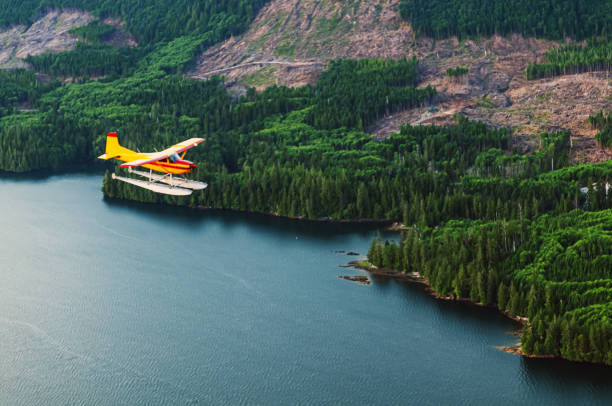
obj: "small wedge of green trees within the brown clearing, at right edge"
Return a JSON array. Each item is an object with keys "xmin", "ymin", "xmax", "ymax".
[{"xmin": 525, "ymin": 40, "xmax": 612, "ymax": 80}]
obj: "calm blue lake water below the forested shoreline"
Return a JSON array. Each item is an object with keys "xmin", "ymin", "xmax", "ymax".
[{"xmin": 0, "ymin": 174, "xmax": 612, "ymax": 405}]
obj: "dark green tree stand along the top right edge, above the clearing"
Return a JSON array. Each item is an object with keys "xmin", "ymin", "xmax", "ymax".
[{"xmin": 400, "ymin": 0, "xmax": 612, "ymax": 40}]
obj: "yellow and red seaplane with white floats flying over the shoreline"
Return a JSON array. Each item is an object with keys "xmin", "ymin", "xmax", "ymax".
[{"xmin": 98, "ymin": 132, "xmax": 208, "ymax": 196}]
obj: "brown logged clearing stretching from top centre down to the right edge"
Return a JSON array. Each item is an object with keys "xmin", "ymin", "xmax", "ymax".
[{"xmin": 189, "ymin": 0, "xmax": 612, "ymax": 162}]
